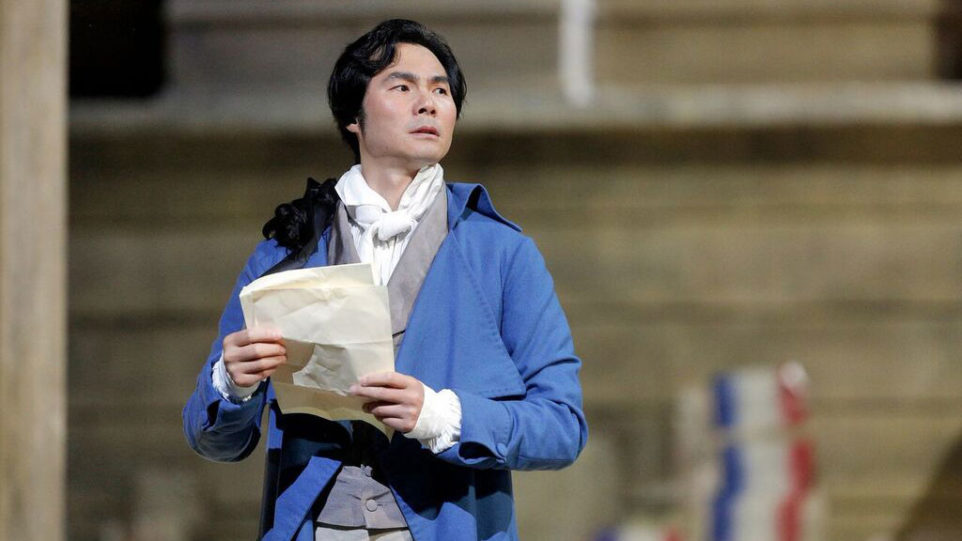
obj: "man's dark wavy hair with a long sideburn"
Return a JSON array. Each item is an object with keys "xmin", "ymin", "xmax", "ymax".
[{"xmin": 327, "ymin": 19, "xmax": 468, "ymax": 163}]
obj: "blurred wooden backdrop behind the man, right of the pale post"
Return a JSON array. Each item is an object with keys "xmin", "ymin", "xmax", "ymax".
[{"xmin": 35, "ymin": 0, "xmax": 962, "ymax": 541}]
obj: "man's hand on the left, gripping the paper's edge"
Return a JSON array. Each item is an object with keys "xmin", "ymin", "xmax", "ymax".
[{"xmin": 224, "ymin": 327, "xmax": 287, "ymax": 387}]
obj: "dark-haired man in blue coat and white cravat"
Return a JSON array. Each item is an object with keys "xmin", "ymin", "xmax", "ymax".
[{"xmin": 184, "ymin": 20, "xmax": 587, "ymax": 541}]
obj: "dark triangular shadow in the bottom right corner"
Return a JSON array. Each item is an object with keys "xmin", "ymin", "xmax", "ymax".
[{"xmin": 895, "ymin": 435, "xmax": 962, "ymax": 541}]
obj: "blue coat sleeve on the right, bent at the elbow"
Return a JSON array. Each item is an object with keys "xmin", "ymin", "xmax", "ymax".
[{"xmin": 438, "ymin": 238, "xmax": 588, "ymax": 470}]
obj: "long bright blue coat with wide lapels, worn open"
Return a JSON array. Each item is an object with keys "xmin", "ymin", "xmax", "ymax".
[{"xmin": 184, "ymin": 184, "xmax": 588, "ymax": 541}]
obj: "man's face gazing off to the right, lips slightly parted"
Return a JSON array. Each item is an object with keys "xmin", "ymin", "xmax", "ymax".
[{"xmin": 347, "ymin": 43, "xmax": 457, "ymax": 171}]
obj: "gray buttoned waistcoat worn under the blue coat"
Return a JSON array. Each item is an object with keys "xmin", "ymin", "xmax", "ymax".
[{"xmin": 317, "ymin": 190, "xmax": 448, "ymax": 528}]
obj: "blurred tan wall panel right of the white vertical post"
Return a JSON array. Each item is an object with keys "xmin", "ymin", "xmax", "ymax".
[{"xmin": 595, "ymin": 0, "xmax": 939, "ymax": 83}]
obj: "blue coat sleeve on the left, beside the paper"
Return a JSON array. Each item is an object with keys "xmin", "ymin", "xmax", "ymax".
[{"xmin": 183, "ymin": 243, "xmax": 282, "ymax": 462}]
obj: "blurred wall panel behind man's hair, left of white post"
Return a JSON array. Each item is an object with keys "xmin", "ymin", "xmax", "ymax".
[{"xmin": 169, "ymin": 0, "xmax": 558, "ymax": 94}]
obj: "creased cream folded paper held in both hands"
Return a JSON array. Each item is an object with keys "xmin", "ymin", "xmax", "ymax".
[{"xmin": 240, "ymin": 263, "xmax": 394, "ymax": 437}]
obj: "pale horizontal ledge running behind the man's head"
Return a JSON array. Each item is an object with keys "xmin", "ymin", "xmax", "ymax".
[{"xmin": 70, "ymin": 81, "xmax": 962, "ymax": 137}]
